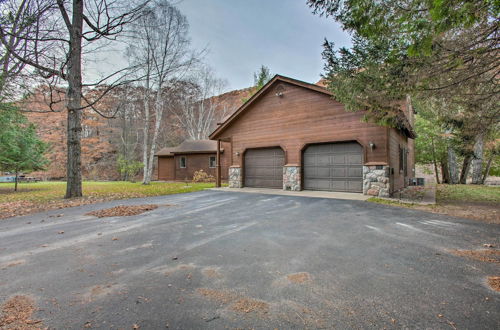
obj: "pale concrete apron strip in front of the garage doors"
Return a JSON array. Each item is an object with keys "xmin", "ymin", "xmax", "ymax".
[{"xmin": 209, "ymin": 187, "xmax": 373, "ymax": 201}]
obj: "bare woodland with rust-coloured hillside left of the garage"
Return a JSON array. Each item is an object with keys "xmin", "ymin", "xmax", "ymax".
[{"xmin": 0, "ymin": 0, "xmax": 247, "ymax": 197}]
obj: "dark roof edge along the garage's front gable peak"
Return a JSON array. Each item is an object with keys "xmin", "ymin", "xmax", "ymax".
[{"xmin": 210, "ymin": 74, "xmax": 333, "ymax": 139}]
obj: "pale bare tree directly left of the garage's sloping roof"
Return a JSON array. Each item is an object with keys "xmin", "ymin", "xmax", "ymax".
[{"xmin": 172, "ymin": 67, "xmax": 227, "ymax": 140}]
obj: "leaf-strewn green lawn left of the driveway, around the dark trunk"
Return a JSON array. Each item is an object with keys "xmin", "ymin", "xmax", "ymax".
[{"xmin": 0, "ymin": 181, "xmax": 214, "ymax": 218}]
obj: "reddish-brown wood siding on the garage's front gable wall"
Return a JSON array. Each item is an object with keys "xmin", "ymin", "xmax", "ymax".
[{"xmin": 219, "ymin": 82, "xmax": 388, "ymax": 166}]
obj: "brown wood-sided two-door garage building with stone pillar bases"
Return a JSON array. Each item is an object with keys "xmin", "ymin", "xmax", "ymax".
[{"xmin": 210, "ymin": 75, "xmax": 415, "ymax": 196}]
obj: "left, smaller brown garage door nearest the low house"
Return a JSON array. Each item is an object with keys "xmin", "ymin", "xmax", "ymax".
[{"xmin": 245, "ymin": 148, "xmax": 285, "ymax": 189}]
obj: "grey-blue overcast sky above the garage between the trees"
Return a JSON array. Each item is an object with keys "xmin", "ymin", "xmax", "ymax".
[{"xmin": 176, "ymin": 0, "xmax": 350, "ymax": 90}]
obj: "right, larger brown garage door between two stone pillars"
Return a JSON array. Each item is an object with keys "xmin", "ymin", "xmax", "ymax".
[{"xmin": 304, "ymin": 142, "xmax": 363, "ymax": 192}]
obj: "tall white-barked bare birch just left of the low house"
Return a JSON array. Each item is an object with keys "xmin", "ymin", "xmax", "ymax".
[{"xmin": 129, "ymin": 0, "xmax": 197, "ymax": 184}]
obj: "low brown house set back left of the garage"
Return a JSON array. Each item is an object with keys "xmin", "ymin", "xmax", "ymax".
[{"xmin": 156, "ymin": 140, "xmax": 227, "ymax": 181}]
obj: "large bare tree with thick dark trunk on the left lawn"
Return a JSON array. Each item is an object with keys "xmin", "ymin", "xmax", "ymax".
[{"xmin": 0, "ymin": 0, "xmax": 144, "ymax": 198}]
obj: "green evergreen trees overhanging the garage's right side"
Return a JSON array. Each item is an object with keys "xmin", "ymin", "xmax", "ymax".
[{"xmin": 308, "ymin": 0, "xmax": 500, "ymax": 184}]
